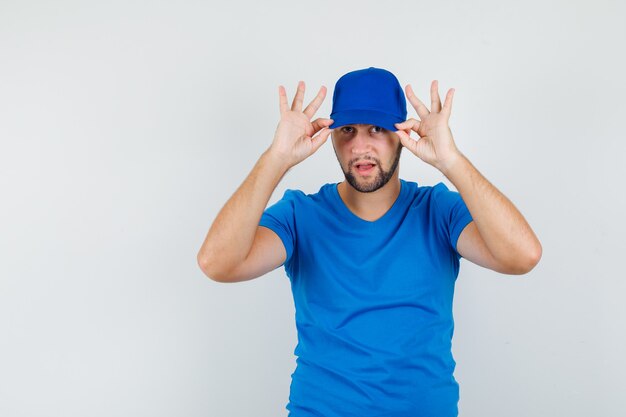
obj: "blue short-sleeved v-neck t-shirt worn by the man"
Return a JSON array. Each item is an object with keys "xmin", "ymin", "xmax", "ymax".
[{"xmin": 259, "ymin": 179, "xmax": 472, "ymax": 417}]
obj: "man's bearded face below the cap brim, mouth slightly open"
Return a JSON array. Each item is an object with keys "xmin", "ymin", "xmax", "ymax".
[{"xmin": 332, "ymin": 124, "xmax": 402, "ymax": 193}]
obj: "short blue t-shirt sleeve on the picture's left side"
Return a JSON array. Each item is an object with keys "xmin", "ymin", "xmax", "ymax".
[{"xmin": 259, "ymin": 190, "xmax": 296, "ymax": 266}]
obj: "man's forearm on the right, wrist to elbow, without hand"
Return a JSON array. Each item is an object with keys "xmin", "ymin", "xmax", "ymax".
[{"xmin": 442, "ymin": 152, "xmax": 541, "ymax": 265}]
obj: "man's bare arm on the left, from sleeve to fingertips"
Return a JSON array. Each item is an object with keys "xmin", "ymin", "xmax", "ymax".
[{"xmin": 197, "ymin": 81, "xmax": 333, "ymax": 281}]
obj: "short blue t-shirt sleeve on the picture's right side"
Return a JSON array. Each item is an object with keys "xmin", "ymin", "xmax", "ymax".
[{"xmin": 433, "ymin": 182, "xmax": 473, "ymax": 258}]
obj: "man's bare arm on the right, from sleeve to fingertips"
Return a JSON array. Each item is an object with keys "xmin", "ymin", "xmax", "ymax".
[{"xmin": 396, "ymin": 80, "xmax": 542, "ymax": 274}]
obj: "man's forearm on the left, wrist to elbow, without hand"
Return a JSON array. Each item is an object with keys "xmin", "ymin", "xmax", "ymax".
[{"xmin": 197, "ymin": 149, "xmax": 289, "ymax": 275}]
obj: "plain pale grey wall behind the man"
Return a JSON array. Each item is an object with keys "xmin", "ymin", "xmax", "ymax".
[{"xmin": 0, "ymin": 0, "xmax": 626, "ymax": 417}]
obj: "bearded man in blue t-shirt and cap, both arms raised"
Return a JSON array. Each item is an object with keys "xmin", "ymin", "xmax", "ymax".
[{"xmin": 198, "ymin": 67, "xmax": 541, "ymax": 417}]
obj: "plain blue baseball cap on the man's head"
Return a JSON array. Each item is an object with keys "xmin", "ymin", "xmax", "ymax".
[{"xmin": 329, "ymin": 67, "xmax": 406, "ymax": 132}]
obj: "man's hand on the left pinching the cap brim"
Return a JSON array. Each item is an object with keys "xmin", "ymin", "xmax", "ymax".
[{"xmin": 269, "ymin": 81, "xmax": 333, "ymax": 168}]
